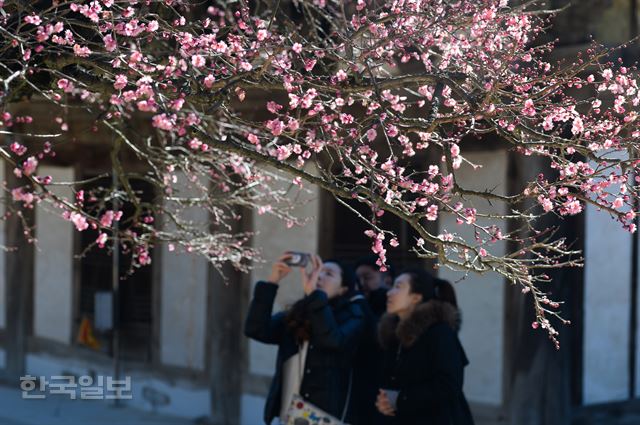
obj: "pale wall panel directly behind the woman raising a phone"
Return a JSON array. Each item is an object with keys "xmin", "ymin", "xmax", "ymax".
[{"xmin": 249, "ymin": 179, "xmax": 321, "ymax": 376}]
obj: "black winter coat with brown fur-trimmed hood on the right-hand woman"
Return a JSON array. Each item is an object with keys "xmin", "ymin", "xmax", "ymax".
[{"xmin": 380, "ymin": 300, "xmax": 473, "ymax": 425}]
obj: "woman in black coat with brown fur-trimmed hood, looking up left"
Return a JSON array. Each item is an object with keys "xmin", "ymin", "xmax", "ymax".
[{"xmin": 376, "ymin": 269, "xmax": 473, "ymax": 425}]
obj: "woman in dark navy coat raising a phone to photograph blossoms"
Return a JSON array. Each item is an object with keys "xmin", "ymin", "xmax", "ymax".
[{"xmin": 245, "ymin": 254, "xmax": 364, "ymax": 424}]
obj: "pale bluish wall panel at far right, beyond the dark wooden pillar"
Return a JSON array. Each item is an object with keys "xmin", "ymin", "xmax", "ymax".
[{"xmin": 583, "ymin": 206, "xmax": 631, "ymax": 404}]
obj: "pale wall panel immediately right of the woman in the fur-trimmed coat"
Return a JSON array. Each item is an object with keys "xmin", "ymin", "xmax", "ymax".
[{"xmin": 438, "ymin": 151, "xmax": 507, "ymax": 405}]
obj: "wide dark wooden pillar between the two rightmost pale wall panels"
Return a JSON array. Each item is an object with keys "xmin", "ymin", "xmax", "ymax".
[{"xmin": 505, "ymin": 155, "xmax": 584, "ymax": 425}]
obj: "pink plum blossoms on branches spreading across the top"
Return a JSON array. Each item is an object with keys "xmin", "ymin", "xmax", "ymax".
[{"xmin": 0, "ymin": 0, "xmax": 640, "ymax": 336}]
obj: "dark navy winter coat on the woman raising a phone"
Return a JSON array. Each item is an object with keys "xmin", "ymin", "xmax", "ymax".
[{"xmin": 245, "ymin": 282, "xmax": 364, "ymax": 424}]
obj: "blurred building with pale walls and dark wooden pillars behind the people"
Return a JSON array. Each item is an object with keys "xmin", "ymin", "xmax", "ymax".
[{"xmin": 0, "ymin": 0, "xmax": 640, "ymax": 425}]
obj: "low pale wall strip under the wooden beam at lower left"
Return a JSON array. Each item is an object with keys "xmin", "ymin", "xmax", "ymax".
[{"xmin": 26, "ymin": 354, "xmax": 211, "ymax": 419}]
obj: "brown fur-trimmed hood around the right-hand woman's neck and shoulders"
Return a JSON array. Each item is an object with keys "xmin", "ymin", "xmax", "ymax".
[{"xmin": 378, "ymin": 300, "xmax": 460, "ymax": 349}]
